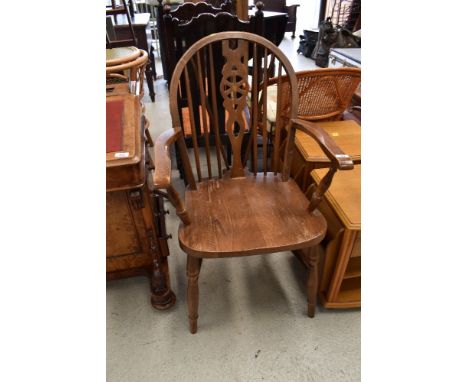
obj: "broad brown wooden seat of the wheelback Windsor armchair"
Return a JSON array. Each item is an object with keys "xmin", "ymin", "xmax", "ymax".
[{"xmin": 179, "ymin": 173, "xmax": 327, "ymax": 257}]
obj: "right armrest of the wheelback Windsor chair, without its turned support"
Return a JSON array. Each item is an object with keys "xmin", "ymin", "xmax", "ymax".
[{"xmin": 291, "ymin": 118, "xmax": 354, "ymax": 170}]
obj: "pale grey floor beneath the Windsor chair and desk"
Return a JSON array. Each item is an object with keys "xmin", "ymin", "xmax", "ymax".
[{"xmin": 107, "ymin": 39, "xmax": 361, "ymax": 382}]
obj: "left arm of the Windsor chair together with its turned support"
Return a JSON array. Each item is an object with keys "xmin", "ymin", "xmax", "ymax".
[{"xmin": 153, "ymin": 128, "xmax": 190, "ymax": 225}]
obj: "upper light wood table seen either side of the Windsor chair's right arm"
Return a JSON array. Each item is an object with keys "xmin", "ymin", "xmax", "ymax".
[{"xmin": 291, "ymin": 120, "xmax": 361, "ymax": 191}]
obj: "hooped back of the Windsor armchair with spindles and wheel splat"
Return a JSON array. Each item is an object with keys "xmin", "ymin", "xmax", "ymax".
[{"xmin": 169, "ymin": 32, "xmax": 298, "ymax": 188}]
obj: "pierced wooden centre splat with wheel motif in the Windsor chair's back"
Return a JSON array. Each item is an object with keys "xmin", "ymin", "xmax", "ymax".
[{"xmin": 220, "ymin": 40, "xmax": 249, "ymax": 178}]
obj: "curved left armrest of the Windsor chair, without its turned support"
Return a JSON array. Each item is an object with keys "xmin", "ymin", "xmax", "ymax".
[{"xmin": 153, "ymin": 129, "xmax": 181, "ymax": 189}]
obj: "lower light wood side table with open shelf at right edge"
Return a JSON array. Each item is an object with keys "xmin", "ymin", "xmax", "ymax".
[{"xmin": 311, "ymin": 165, "xmax": 361, "ymax": 308}]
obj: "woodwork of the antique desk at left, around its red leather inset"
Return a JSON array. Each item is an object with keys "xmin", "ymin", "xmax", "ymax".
[{"xmin": 106, "ymin": 93, "xmax": 175, "ymax": 309}]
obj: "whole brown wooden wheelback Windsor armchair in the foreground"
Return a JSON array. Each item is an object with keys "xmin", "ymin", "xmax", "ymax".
[{"xmin": 153, "ymin": 32, "xmax": 353, "ymax": 333}]
